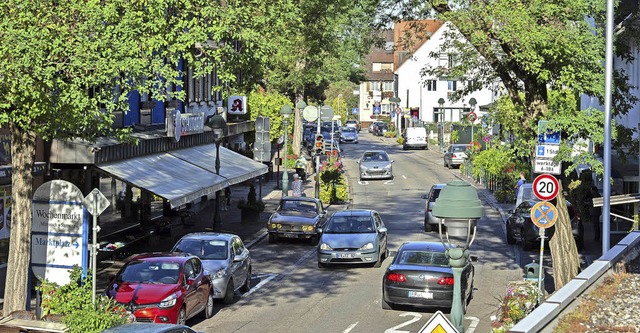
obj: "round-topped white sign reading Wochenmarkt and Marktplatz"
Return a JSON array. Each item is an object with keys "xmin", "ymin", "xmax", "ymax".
[{"xmin": 31, "ymin": 180, "xmax": 89, "ymax": 285}]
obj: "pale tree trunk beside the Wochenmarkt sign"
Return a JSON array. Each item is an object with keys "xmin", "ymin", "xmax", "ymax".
[{"xmin": 3, "ymin": 123, "xmax": 36, "ymax": 315}]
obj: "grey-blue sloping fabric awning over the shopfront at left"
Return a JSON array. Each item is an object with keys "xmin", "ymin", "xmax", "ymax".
[{"xmin": 97, "ymin": 145, "xmax": 268, "ymax": 208}]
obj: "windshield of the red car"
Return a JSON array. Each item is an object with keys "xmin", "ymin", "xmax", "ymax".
[{"xmin": 116, "ymin": 260, "xmax": 180, "ymax": 284}]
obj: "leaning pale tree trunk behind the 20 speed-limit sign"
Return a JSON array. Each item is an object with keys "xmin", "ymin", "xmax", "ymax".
[{"xmin": 549, "ymin": 185, "xmax": 580, "ymax": 290}]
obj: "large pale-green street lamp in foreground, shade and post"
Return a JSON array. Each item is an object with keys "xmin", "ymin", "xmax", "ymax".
[{"xmin": 433, "ymin": 180, "xmax": 483, "ymax": 332}]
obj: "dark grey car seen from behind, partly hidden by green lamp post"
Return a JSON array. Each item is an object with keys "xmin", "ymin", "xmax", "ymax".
[{"xmin": 382, "ymin": 242, "xmax": 475, "ymax": 309}]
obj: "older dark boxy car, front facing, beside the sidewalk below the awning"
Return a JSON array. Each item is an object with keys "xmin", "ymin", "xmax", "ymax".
[{"xmin": 267, "ymin": 197, "xmax": 327, "ymax": 245}]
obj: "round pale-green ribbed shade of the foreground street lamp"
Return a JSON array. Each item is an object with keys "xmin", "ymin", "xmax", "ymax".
[{"xmin": 433, "ymin": 180, "xmax": 484, "ymax": 219}]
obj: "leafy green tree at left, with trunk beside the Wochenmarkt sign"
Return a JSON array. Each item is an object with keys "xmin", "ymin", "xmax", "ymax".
[{"xmin": 0, "ymin": 0, "xmax": 288, "ymax": 313}]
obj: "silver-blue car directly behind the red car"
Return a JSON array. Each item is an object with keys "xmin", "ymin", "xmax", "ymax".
[{"xmin": 171, "ymin": 232, "xmax": 251, "ymax": 304}]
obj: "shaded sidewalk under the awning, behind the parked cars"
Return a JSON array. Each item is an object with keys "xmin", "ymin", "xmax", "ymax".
[{"xmin": 96, "ymin": 172, "xmax": 315, "ymax": 293}]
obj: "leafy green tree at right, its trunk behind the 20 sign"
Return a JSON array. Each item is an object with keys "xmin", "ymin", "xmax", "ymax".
[{"xmin": 384, "ymin": 0, "xmax": 637, "ymax": 288}]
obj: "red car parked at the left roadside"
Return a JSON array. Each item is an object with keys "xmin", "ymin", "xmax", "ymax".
[{"xmin": 105, "ymin": 253, "xmax": 213, "ymax": 325}]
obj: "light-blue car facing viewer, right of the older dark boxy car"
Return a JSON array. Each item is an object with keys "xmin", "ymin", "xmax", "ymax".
[{"xmin": 318, "ymin": 209, "xmax": 389, "ymax": 268}]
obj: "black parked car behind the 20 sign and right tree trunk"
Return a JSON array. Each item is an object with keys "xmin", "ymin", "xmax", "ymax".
[{"xmin": 507, "ymin": 200, "xmax": 584, "ymax": 251}]
